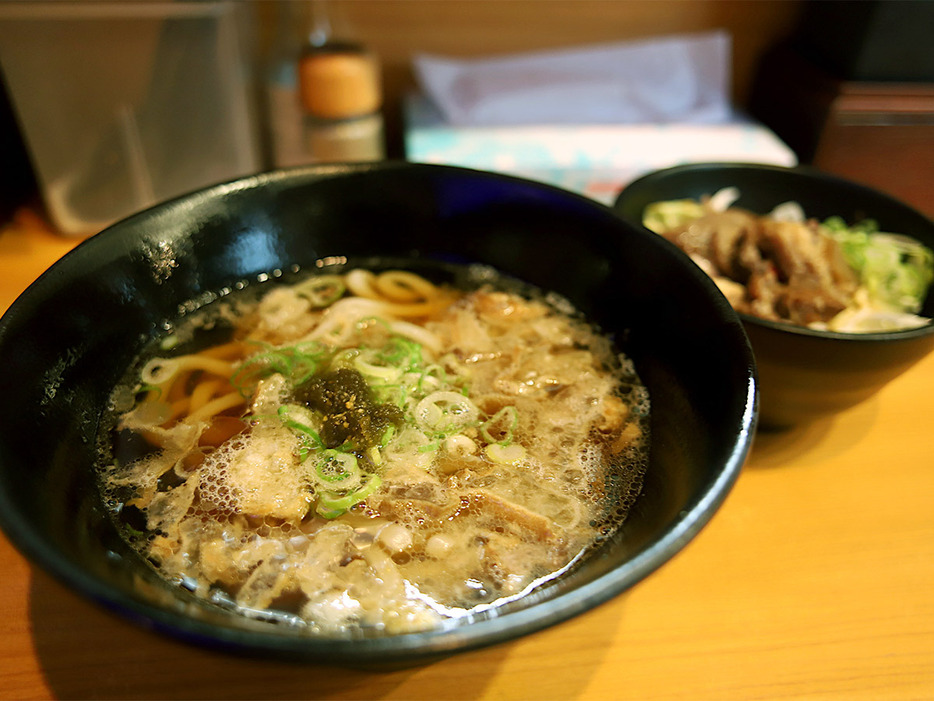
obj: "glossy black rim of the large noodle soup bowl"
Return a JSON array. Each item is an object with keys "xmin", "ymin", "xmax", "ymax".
[{"xmin": 0, "ymin": 162, "xmax": 758, "ymax": 667}]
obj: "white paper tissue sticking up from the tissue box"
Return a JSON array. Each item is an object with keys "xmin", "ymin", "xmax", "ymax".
[{"xmin": 414, "ymin": 31, "xmax": 732, "ymax": 126}]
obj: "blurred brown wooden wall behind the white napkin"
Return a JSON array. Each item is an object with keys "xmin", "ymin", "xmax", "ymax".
[{"xmin": 257, "ymin": 0, "xmax": 803, "ymax": 156}]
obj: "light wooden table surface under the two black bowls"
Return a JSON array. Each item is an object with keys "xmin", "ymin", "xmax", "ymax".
[{"xmin": 0, "ymin": 213, "xmax": 934, "ymax": 701}]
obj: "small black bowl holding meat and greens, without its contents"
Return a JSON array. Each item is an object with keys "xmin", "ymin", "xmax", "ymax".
[{"xmin": 614, "ymin": 163, "xmax": 934, "ymax": 428}]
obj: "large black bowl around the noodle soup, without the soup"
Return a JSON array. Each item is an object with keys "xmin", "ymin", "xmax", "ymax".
[{"xmin": 0, "ymin": 164, "xmax": 756, "ymax": 665}]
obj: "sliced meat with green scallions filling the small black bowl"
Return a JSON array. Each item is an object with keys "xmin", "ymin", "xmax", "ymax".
[{"xmin": 643, "ymin": 188, "xmax": 934, "ymax": 332}]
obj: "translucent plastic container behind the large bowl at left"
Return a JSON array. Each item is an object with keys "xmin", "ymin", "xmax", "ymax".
[{"xmin": 0, "ymin": 2, "xmax": 261, "ymax": 235}]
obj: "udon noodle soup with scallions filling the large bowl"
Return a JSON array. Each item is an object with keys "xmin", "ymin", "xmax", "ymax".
[{"xmin": 102, "ymin": 269, "xmax": 648, "ymax": 634}]
